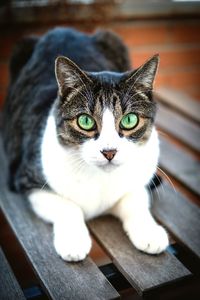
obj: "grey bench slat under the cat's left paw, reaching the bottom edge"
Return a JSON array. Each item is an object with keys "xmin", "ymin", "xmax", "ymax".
[{"xmin": 0, "ymin": 138, "xmax": 119, "ymax": 300}]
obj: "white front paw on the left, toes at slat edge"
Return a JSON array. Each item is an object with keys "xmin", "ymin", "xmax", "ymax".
[{"xmin": 54, "ymin": 224, "xmax": 92, "ymax": 262}]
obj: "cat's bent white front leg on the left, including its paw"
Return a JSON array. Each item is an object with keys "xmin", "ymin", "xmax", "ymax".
[{"xmin": 29, "ymin": 190, "xmax": 92, "ymax": 261}]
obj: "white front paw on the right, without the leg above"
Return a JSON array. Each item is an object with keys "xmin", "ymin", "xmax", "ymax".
[{"xmin": 126, "ymin": 224, "xmax": 169, "ymax": 254}]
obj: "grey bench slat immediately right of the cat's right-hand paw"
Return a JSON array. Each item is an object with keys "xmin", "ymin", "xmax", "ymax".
[{"xmin": 153, "ymin": 181, "xmax": 200, "ymax": 258}]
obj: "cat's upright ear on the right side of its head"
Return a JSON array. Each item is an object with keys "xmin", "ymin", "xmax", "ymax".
[{"xmin": 126, "ymin": 54, "xmax": 160, "ymax": 90}]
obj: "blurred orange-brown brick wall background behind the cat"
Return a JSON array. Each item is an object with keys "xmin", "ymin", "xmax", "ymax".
[{"xmin": 0, "ymin": 0, "xmax": 200, "ymax": 106}]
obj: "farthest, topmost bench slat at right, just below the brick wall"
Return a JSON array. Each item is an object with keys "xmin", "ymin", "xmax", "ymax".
[{"xmin": 155, "ymin": 87, "xmax": 200, "ymax": 122}]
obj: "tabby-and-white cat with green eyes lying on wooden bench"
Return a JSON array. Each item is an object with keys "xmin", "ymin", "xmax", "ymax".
[{"xmin": 3, "ymin": 28, "xmax": 168, "ymax": 261}]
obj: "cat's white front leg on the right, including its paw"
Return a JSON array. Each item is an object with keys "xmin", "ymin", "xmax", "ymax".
[{"xmin": 110, "ymin": 188, "xmax": 169, "ymax": 254}]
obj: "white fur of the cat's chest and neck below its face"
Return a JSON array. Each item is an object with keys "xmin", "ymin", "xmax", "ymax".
[{"xmin": 41, "ymin": 116, "xmax": 158, "ymax": 219}]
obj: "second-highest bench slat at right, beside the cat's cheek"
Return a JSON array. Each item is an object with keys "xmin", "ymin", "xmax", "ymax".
[{"xmin": 156, "ymin": 103, "xmax": 200, "ymax": 151}]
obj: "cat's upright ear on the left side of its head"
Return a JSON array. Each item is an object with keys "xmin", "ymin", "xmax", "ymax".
[{"xmin": 55, "ymin": 56, "xmax": 92, "ymax": 96}]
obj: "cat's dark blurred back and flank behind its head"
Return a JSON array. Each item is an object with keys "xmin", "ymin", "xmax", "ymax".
[{"xmin": 3, "ymin": 28, "xmax": 129, "ymax": 192}]
